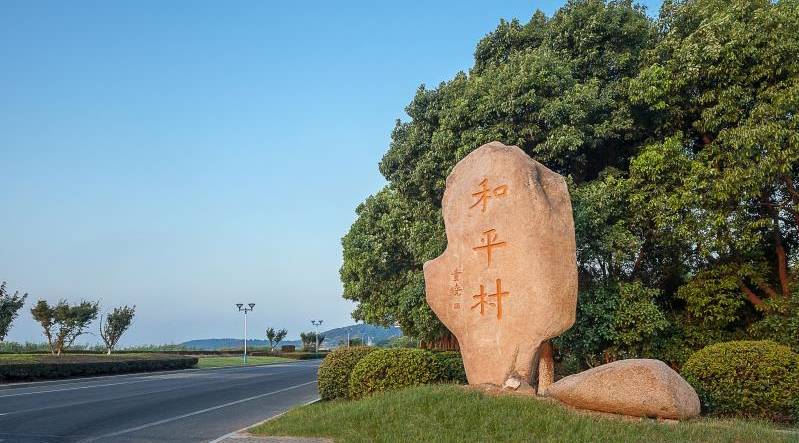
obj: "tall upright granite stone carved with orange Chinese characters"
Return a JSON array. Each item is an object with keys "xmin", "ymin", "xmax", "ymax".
[{"xmin": 424, "ymin": 142, "xmax": 577, "ymax": 386}]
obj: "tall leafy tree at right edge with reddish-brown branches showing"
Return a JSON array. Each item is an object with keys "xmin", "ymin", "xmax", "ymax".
[{"xmin": 629, "ymin": 0, "xmax": 799, "ymax": 358}]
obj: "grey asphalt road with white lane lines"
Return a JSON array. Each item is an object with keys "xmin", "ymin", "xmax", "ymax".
[{"xmin": 0, "ymin": 361, "xmax": 319, "ymax": 443}]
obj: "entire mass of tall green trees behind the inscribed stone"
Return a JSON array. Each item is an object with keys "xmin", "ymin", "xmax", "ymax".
[{"xmin": 341, "ymin": 0, "xmax": 799, "ymax": 369}]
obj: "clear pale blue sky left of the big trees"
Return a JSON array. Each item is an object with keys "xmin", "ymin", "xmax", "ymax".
[{"xmin": 0, "ymin": 0, "xmax": 656, "ymax": 345}]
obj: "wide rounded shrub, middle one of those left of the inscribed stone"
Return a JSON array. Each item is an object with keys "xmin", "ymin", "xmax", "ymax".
[{"xmin": 349, "ymin": 348, "xmax": 442, "ymax": 399}]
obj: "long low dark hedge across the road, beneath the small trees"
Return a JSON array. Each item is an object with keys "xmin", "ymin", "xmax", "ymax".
[{"xmin": 0, "ymin": 354, "xmax": 197, "ymax": 381}]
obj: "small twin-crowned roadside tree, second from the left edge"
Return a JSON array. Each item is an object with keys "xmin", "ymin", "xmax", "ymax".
[{"xmin": 31, "ymin": 300, "xmax": 100, "ymax": 355}]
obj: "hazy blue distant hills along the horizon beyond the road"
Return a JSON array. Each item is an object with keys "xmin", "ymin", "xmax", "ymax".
[{"xmin": 181, "ymin": 325, "xmax": 402, "ymax": 351}]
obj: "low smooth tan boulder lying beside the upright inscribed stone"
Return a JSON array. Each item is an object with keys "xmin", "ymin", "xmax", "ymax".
[{"xmin": 545, "ymin": 359, "xmax": 699, "ymax": 420}]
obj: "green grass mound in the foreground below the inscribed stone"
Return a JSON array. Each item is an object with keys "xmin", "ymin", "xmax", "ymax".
[{"xmin": 251, "ymin": 385, "xmax": 799, "ymax": 443}]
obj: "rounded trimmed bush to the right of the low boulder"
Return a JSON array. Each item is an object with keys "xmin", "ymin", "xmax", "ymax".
[{"xmin": 682, "ymin": 341, "xmax": 799, "ymax": 421}]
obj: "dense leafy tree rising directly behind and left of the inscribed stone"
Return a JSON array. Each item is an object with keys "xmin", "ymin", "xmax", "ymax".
[{"xmin": 341, "ymin": 1, "xmax": 655, "ymax": 340}]
